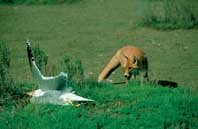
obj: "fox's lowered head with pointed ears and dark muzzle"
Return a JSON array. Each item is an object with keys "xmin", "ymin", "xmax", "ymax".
[{"xmin": 123, "ymin": 56, "xmax": 139, "ymax": 78}]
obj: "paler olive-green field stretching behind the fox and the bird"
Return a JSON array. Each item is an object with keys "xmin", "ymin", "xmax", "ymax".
[{"xmin": 0, "ymin": 0, "xmax": 198, "ymax": 87}]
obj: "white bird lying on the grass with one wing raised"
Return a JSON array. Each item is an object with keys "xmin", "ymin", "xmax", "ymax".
[{"xmin": 27, "ymin": 40, "xmax": 93, "ymax": 105}]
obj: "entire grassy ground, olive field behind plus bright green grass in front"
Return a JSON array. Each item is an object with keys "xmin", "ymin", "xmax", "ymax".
[{"xmin": 0, "ymin": 0, "xmax": 198, "ymax": 129}]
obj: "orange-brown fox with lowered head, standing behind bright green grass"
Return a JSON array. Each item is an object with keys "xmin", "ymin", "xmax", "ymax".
[{"xmin": 98, "ymin": 46, "xmax": 148, "ymax": 82}]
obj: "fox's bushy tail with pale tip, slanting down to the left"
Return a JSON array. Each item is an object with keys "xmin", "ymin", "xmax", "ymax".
[{"xmin": 98, "ymin": 53, "xmax": 120, "ymax": 82}]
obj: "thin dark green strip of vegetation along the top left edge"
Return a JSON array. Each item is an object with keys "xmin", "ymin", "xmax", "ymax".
[{"xmin": 0, "ymin": 0, "xmax": 82, "ymax": 4}]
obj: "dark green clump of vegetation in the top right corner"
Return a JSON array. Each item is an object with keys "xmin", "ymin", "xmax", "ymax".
[{"xmin": 142, "ymin": 0, "xmax": 198, "ymax": 29}]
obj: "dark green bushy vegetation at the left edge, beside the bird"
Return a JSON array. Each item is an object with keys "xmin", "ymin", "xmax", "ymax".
[{"xmin": 0, "ymin": 41, "xmax": 29, "ymax": 107}]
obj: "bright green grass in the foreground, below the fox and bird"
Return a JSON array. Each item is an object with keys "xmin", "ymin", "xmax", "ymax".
[{"xmin": 0, "ymin": 83, "xmax": 198, "ymax": 129}]
